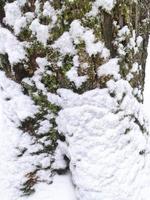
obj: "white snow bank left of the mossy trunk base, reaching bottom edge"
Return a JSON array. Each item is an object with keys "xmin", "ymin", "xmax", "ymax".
[{"xmin": 0, "ymin": 71, "xmax": 76, "ymax": 200}]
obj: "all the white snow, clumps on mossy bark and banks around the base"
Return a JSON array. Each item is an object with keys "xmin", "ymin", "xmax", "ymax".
[{"xmin": 0, "ymin": 0, "xmax": 150, "ymax": 200}]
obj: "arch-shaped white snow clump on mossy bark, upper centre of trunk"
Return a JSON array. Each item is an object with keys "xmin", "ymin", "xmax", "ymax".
[{"xmin": 52, "ymin": 20, "xmax": 110, "ymax": 59}]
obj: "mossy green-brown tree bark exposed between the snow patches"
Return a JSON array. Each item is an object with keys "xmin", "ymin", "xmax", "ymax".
[{"xmin": 0, "ymin": 0, "xmax": 150, "ymax": 197}]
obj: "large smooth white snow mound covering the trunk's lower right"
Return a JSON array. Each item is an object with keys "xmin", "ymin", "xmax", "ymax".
[{"xmin": 57, "ymin": 80, "xmax": 150, "ymax": 200}]
